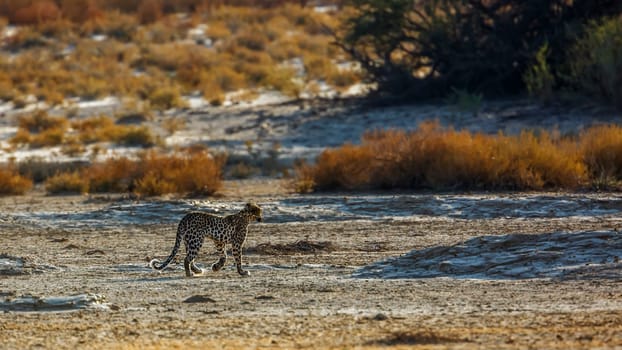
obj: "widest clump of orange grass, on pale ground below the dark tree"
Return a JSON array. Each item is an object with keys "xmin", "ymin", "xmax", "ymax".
[{"xmin": 295, "ymin": 122, "xmax": 596, "ymax": 192}]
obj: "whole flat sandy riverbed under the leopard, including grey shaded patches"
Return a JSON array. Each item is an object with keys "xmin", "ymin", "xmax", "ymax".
[{"xmin": 0, "ymin": 180, "xmax": 622, "ymax": 349}]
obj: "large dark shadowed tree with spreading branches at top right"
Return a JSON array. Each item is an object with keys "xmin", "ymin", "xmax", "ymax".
[{"xmin": 337, "ymin": 0, "xmax": 622, "ymax": 97}]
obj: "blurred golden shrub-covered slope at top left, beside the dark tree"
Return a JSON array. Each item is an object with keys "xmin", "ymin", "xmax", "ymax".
[{"xmin": 0, "ymin": 0, "xmax": 360, "ymax": 106}]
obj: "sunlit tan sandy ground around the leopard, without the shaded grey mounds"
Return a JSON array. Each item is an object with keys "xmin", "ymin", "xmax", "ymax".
[{"xmin": 0, "ymin": 182, "xmax": 622, "ymax": 349}]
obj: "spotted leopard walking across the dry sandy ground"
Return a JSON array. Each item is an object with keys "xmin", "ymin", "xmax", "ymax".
[{"xmin": 149, "ymin": 202, "xmax": 263, "ymax": 277}]
